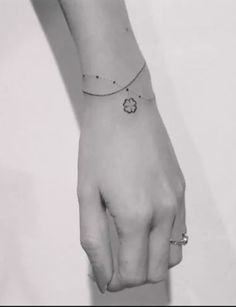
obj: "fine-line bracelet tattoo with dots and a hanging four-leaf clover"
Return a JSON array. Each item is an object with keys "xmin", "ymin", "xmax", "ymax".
[{"xmin": 83, "ymin": 62, "xmax": 155, "ymax": 114}]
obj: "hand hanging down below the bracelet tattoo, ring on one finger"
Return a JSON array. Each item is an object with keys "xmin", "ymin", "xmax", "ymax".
[{"xmin": 78, "ymin": 93, "xmax": 186, "ymax": 292}]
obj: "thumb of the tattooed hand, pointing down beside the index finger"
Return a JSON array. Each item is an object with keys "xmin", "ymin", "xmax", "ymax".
[{"xmin": 78, "ymin": 188, "xmax": 113, "ymax": 293}]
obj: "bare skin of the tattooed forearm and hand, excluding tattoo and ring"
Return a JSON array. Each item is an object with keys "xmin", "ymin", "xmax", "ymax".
[{"xmin": 60, "ymin": 0, "xmax": 186, "ymax": 292}]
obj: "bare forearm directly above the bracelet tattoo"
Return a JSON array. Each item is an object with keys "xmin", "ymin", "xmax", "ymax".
[{"xmin": 60, "ymin": 0, "xmax": 144, "ymax": 84}]
